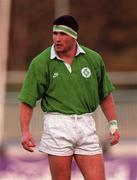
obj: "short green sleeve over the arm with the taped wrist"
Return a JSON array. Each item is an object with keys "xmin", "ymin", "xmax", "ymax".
[{"xmin": 98, "ymin": 54, "xmax": 115, "ymax": 102}]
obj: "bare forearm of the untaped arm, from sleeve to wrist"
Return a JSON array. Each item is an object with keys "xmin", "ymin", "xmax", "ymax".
[{"xmin": 20, "ymin": 103, "xmax": 33, "ymax": 133}]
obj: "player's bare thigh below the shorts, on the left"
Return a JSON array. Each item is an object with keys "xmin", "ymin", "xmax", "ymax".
[{"xmin": 48, "ymin": 155, "xmax": 72, "ymax": 180}]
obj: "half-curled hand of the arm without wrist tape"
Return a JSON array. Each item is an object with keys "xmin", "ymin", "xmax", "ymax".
[{"xmin": 21, "ymin": 132, "xmax": 36, "ymax": 152}]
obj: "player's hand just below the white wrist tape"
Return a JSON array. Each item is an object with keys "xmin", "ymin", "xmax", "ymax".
[{"xmin": 109, "ymin": 129, "xmax": 120, "ymax": 145}]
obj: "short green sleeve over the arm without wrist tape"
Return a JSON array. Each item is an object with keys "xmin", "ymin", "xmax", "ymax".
[{"xmin": 18, "ymin": 61, "xmax": 46, "ymax": 107}]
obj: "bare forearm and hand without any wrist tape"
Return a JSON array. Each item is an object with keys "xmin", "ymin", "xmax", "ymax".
[{"xmin": 20, "ymin": 103, "xmax": 36, "ymax": 152}]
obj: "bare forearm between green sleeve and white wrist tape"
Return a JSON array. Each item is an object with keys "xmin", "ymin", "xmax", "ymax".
[{"xmin": 100, "ymin": 94, "xmax": 117, "ymax": 121}]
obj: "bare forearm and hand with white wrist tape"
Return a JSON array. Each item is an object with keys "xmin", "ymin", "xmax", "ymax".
[{"xmin": 100, "ymin": 93, "xmax": 120, "ymax": 145}]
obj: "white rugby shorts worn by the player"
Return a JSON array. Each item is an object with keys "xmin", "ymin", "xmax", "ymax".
[{"xmin": 39, "ymin": 113, "xmax": 102, "ymax": 156}]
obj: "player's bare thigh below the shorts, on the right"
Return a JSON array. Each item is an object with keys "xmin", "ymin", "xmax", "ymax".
[{"xmin": 74, "ymin": 154, "xmax": 105, "ymax": 180}]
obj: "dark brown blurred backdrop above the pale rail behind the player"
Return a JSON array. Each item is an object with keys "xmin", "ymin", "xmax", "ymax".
[{"xmin": 7, "ymin": 0, "xmax": 137, "ymax": 71}]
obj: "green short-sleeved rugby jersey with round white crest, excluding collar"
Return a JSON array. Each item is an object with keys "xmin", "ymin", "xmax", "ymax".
[{"xmin": 18, "ymin": 46, "xmax": 115, "ymax": 114}]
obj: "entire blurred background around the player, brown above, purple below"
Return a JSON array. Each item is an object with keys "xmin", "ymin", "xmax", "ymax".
[{"xmin": 0, "ymin": 0, "xmax": 137, "ymax": 180}]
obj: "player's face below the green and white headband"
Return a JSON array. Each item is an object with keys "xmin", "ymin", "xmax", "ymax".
[{"xmin": 53, "ymin": 31, "xmax": 76, "ymax": 53}]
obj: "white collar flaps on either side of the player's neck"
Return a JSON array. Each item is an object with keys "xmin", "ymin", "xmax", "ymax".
[{"xmin": 50, "ymin": 43, "xmax": 85, "ymax": 60}]
